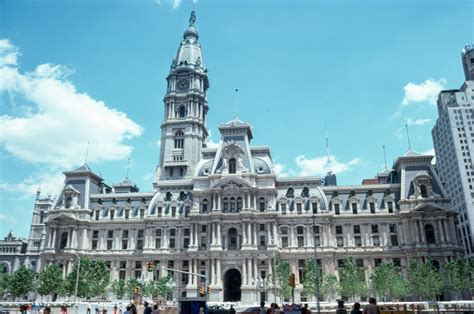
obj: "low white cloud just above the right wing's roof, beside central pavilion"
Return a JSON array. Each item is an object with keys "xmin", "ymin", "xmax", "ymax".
[{"xmin": 295, "ymin": 155, "xmax": 362, "ymax": 176}]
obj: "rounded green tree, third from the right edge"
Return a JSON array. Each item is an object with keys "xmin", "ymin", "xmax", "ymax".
[{"xmin": 370, "ymin": 262, "xmax": 408, "ymax": 300}]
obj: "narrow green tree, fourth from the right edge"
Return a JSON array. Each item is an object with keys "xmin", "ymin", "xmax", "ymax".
[{"xmin": 339, "ymin": 258, "xmax": 367, "ymax": 299}]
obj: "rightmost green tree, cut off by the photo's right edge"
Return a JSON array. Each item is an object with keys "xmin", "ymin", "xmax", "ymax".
[{"xmin": 444, "ymin": 257, "xmax": 474, "ymax": 293}]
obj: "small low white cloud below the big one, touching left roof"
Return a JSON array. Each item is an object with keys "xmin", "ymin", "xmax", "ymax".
[{"xmin": 0, "ymin": 170, "xmax": 64, "ymax": 199}]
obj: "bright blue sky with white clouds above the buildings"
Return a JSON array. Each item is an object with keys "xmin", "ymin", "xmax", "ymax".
[{"xmin": 0, "ymin": 0, "xmax": 474, "ymax": 237}]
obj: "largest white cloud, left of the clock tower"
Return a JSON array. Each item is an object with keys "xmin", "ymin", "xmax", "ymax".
[{"xmin": 0, "ymin": 41, "xmax": 142, "ymax": 172}]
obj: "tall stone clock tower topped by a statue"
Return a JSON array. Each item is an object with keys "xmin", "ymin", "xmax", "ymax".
[{"xmin": 154, "ymin": 11, "xmax": 209, "ymax": 186}]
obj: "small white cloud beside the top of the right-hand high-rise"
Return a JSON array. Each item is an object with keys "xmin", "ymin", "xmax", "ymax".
[{"xmin": 402, "ymin": 78, "xmax": 446, "ymax": 106}]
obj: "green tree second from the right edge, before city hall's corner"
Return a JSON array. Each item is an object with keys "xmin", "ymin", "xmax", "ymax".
[{"xmin": 408, "ymin": 259, "xmax": 443, "ymax": 300}]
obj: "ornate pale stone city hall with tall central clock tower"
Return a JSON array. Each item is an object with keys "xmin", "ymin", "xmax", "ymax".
[{"xmin": 0, "ymin": 12, "xmax": 462, "ymax": 302}]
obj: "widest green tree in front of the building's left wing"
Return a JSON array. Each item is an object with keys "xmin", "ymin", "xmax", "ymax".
[{"xmin": 64, "ymin": 257, "xmax": 110, "ymax": 298}]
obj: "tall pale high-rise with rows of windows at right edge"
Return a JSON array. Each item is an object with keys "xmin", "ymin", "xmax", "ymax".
[{"xmin": 432, "ymin": 45, "xmax": 474, "ymax": 257}]
